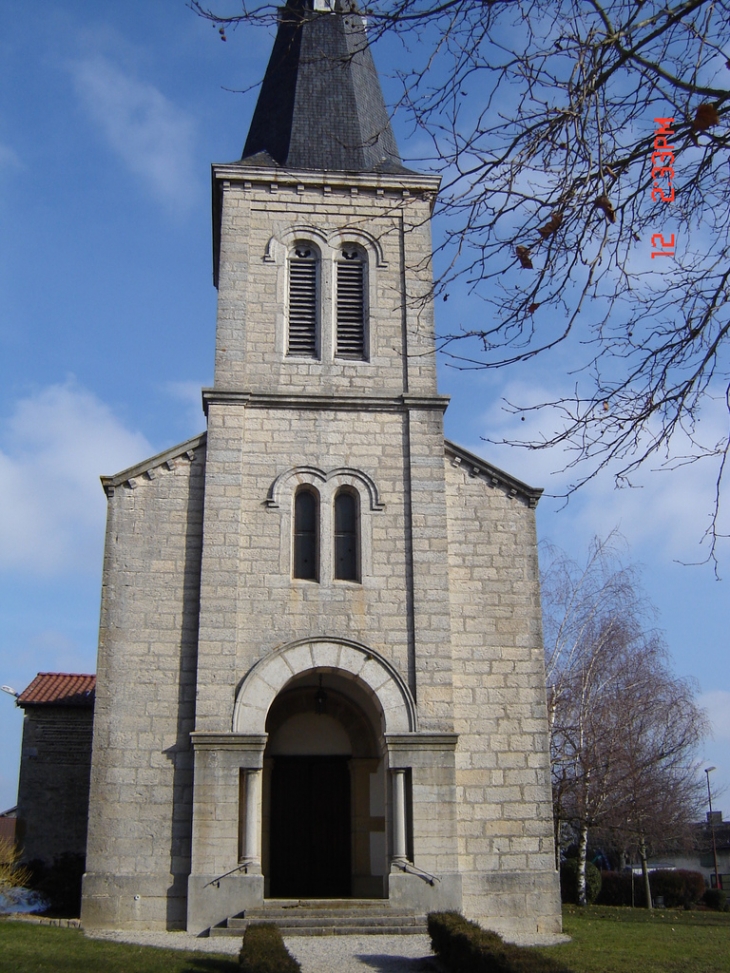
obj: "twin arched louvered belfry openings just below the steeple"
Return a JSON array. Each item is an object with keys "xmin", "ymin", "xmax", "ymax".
[{"xmin": 287, "ymin": 242, "xmax": 367, "ymax": 361}]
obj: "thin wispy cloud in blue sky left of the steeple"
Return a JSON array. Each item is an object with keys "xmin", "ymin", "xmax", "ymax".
[{"xmin": 70, "ymin": 55, "xmax": 196, "ymax": 210}]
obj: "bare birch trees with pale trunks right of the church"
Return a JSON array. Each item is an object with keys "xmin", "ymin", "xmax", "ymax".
[{"xmin": 543, "ymin": 534, "xmax": 707, "ymax": 905}]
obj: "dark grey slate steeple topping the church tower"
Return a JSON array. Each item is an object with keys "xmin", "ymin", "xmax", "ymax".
[{"xmin": 241, "ymin": 0, "xmax": 408, "ymax": 173}]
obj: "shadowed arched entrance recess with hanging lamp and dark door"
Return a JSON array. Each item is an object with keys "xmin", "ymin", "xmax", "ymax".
[{"xmin": 262, "ymin": 668, "xmax": 387, "ymax": 899}]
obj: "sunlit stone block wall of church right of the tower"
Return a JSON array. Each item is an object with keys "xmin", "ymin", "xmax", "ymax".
[{"xmin": 447, "ymin": 455, "xmax": 561, "ymax": 933}]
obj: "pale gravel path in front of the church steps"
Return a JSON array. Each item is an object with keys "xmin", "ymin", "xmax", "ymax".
[{"xmin": 87, "ymin": 932, "xmax": 441, "ymax": 973}]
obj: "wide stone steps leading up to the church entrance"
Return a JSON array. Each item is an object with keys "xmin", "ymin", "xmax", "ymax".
[{"xmin": 210, "ymin": 899, "xmax": 426, "ymax": 936}]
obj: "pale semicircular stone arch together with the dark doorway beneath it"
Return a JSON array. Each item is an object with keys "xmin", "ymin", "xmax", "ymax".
[{"xmin": 233, "ymin": 637, "xmax": 416, "ymax": 898}]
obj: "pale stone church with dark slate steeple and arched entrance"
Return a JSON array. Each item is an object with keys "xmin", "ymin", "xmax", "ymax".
[{"xmin": 82, "ymin": 0, "xmax": 561, "ymax": 935}]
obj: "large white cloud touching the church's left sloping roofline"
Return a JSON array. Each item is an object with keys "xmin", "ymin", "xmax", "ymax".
[{"xmin": 0, "ymin": 383, "xmax": 154, "ymax": 575}]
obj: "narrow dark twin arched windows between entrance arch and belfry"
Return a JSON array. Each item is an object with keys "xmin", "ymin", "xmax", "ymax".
[{"xmin": 293, "ymin": 486, "xmax": 360, "ymax": 581}]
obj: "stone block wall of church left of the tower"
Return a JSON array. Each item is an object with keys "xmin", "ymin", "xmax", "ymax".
[{"xmin": 82, "ymin": 437, "xmax": 205, "ymax": 929}]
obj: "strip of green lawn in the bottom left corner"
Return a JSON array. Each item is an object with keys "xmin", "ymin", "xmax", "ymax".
[{"xmin": 0, "ymin": 920, "xmax": 236, "ymax": 973}]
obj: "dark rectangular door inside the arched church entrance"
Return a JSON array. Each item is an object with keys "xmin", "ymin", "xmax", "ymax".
[{"xmin": 269, "ymin": 757, "xmax": 352, "ymax": 899}]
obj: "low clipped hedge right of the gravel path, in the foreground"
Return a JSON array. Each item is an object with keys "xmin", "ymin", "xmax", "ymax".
[{"xmin": 428, "ymin": 912, "xmax": 571, "ymax": 973}]
